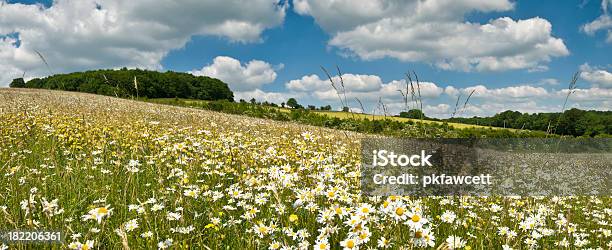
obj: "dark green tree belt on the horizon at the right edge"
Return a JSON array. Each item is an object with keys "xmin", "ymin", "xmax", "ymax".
[{"xmin": 447, "ymin": 108, "xmax": 612, "ymax": 137}]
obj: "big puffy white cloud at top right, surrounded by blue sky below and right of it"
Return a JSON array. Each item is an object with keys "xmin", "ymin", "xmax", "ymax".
[{"xmin": 294, "ymin": 0, "xmax": 569, "ymax": 71}]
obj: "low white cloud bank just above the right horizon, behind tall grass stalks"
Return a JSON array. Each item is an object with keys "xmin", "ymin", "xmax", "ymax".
[{"xmin": 285, "ymin": 71, "xmax": 612, "ymax": 118}]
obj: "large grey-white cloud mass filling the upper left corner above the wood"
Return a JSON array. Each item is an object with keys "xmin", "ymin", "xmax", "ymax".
[{"xmin": 0, "ymin": 0, "xmax": 287, "ymax": 86}]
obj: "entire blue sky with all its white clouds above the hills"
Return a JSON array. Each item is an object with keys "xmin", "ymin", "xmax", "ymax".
[{"xmin": 0, "ymin": 0, "xmax": 612, "ymax": 117}]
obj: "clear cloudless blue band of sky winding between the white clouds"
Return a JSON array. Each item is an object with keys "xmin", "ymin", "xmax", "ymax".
[{"xmin": 162, "ymin": 1, "xmax": 612, "ymax": 90}]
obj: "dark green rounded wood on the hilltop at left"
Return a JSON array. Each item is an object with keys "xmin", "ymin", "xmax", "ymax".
[{"xmin": 11, "ymin": 68, "xmax": 234, "ymax": 101}]
